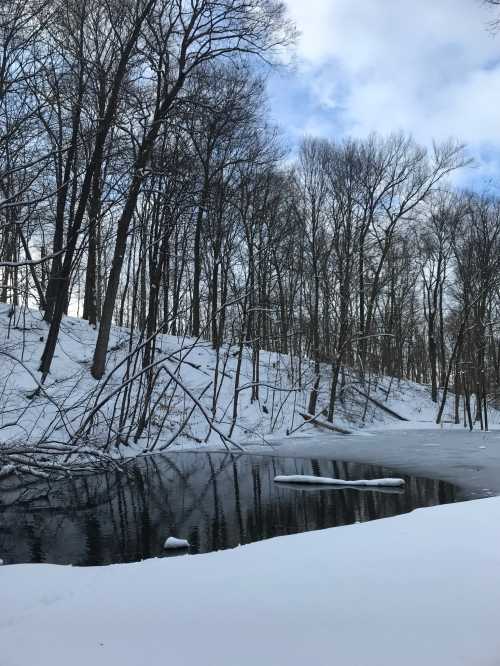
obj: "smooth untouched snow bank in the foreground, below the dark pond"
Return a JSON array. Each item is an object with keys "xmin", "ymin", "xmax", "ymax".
[{"xmin": 0, "ymin": 498, "xmax": 500, "ymax": 666}]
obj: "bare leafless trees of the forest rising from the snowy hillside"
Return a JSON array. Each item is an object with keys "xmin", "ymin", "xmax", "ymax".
[{"xmin": 0, "ymin": 0, "xmax": 500, "ymax": 472}]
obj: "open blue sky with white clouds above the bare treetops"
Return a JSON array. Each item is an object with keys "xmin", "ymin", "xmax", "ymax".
[{"xmin": 269, "ymin": 0, "xmax": 500, "ymax": 187}]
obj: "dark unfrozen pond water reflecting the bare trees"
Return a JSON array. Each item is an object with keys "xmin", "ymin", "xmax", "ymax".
[{"xmin": 0, "ymin": 453, "xmax": 458, "ymax": 565}]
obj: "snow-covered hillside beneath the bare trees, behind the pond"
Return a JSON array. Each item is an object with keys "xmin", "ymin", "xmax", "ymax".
[{"xmin": 0, "ymin": 305, "xmax": 500, "ymax": 470}]
